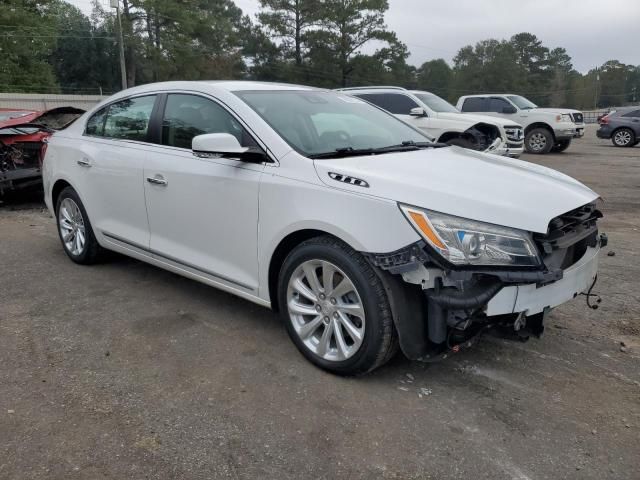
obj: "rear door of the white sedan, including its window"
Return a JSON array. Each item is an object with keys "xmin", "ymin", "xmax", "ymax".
[{"xmin": 74, "ymin": 95, "xmax": 157, "ymax": 248}]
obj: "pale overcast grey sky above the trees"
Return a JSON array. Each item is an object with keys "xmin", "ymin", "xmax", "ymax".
[{"xmin": 69, "ymin": 0, "xmax": 640, "ymax": 73}]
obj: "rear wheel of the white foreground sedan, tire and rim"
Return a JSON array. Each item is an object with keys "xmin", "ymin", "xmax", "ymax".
[{"xmin": 56, "ymin": 187, "xmax": 103, "ymax": 265}]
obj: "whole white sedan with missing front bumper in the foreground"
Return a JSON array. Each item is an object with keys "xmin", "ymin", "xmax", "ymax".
[{"xmin": 43, "ymin": 81, "xmax": 606, "ymax": 375}]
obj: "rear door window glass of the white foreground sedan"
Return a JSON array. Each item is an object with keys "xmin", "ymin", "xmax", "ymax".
[{"xmin": 103, "ymin": 95, "xmax": 156, "ymax": 142}]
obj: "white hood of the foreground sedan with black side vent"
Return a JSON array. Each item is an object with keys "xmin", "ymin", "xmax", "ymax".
[{"xmin": 314, "ymin": 147, "xmax": 598, "ymax": 233}]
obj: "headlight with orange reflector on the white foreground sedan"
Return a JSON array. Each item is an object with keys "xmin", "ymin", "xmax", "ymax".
[{"xmin": 400, "ymin": 205, "xmax": 540, "ymax": 267}]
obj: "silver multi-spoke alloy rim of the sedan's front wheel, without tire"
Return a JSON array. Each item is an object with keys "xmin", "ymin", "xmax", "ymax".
[{"xmin": 287, "ymin": 259, "xmax": 366, "ymax": 362}]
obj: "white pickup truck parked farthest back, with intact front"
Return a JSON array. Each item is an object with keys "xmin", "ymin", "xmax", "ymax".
[{"xmin": 457, "ymin": 94, "xmax": 584, "ymax": 154}]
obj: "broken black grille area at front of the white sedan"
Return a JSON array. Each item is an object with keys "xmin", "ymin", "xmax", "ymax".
[{"xmin": 533, "ymin": 203, "xmax": 602, "ymax": 270}]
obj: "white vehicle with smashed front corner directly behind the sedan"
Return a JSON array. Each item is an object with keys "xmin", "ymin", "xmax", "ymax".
[{"xmin": 338, "ymin": 87, "xmax": 524, "ymax": 158}]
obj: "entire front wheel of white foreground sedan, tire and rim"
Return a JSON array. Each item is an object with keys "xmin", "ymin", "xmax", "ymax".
[{"xmin": 278, "ymin": 236, "xmax": 397, "ymax": 375}]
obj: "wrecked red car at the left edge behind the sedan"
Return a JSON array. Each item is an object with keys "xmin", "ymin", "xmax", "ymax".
[{"xmin": 0, "ymin": 107, "xmax": 84, "ymax": 196}]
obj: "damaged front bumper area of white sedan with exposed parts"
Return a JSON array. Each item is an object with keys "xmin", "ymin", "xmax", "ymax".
[{"xmin": 367, "ymin": 206, "xmax": 607, "ymax": 361}]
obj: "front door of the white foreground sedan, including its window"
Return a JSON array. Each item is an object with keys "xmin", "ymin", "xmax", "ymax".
[{"xmin": 144, "ymin": 93, "xmax": 264, "ymax": 293}]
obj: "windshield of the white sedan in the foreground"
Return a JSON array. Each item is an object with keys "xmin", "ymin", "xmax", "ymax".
[{"xmin": 234, "ymin": 90, "xmax": 429, "ymax": 157}]
